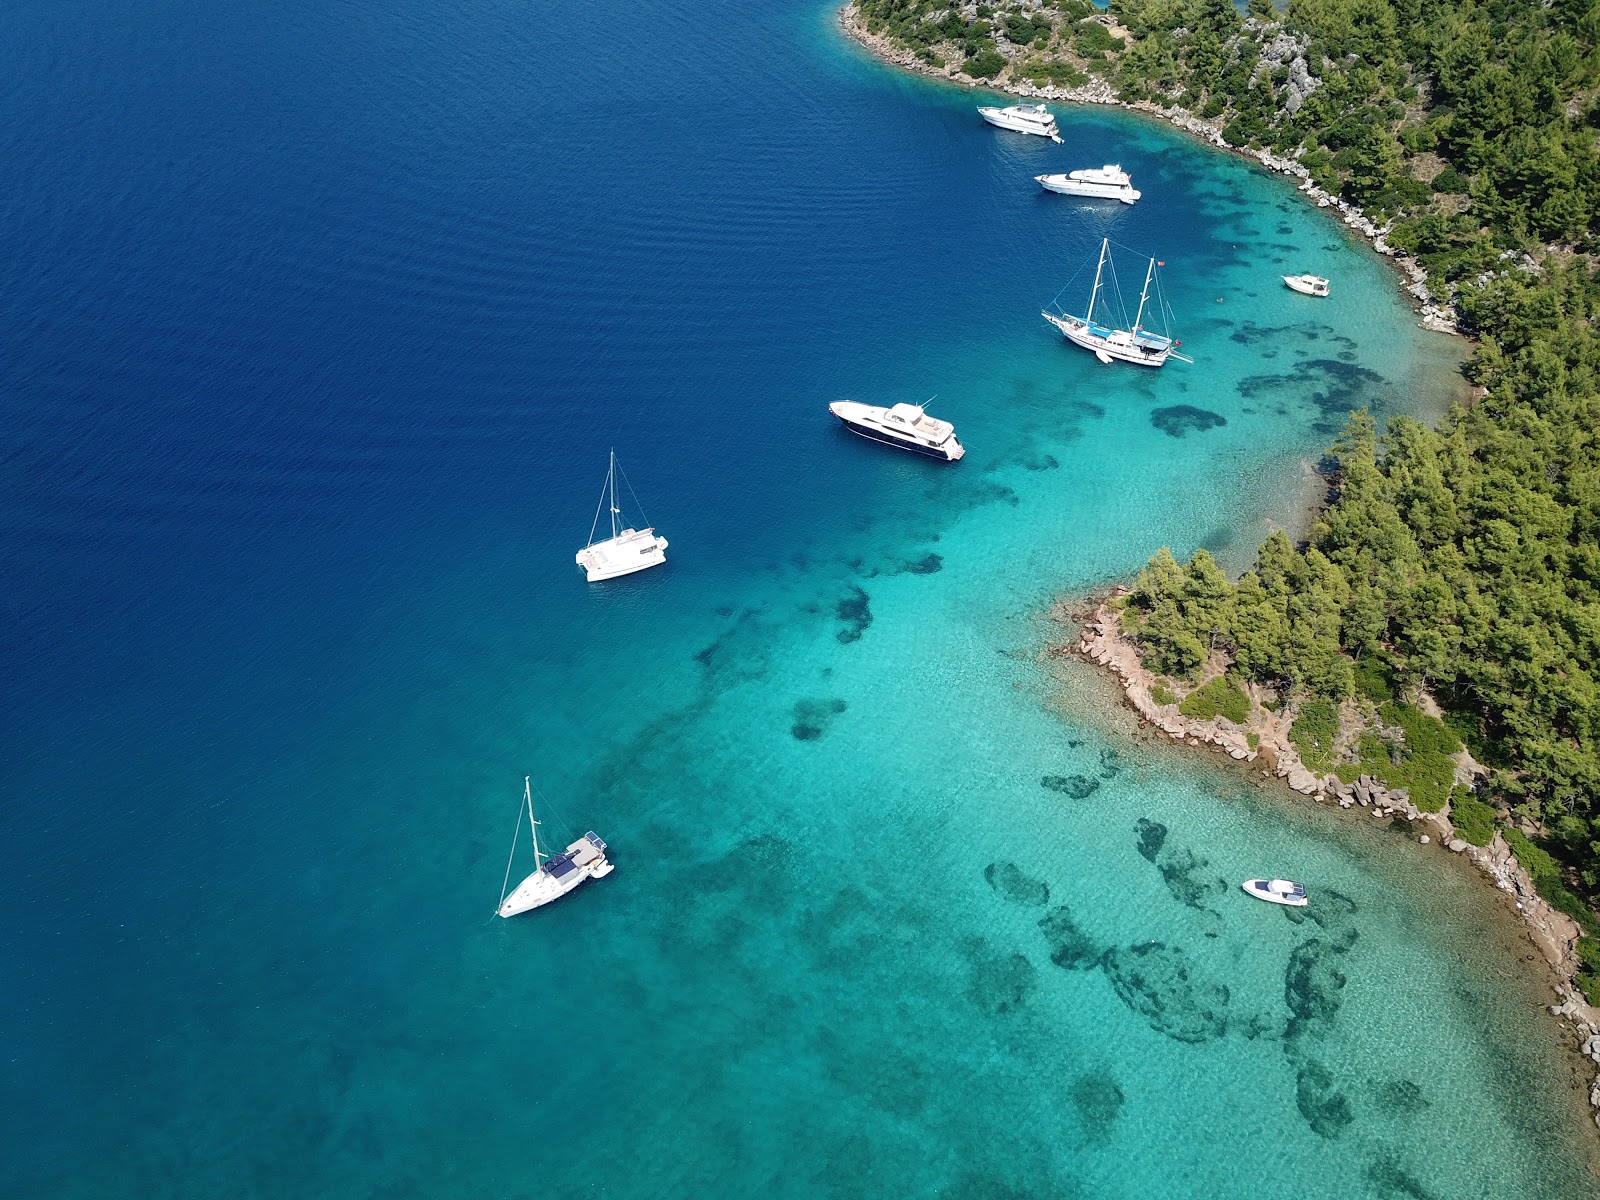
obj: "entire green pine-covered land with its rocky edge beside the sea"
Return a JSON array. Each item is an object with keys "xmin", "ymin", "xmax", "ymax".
[{"xmin": 840, "ymin": 0, "xmax": 1600, "ymax": 1122}]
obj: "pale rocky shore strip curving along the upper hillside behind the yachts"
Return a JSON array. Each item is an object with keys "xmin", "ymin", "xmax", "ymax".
[{"xmin": 838, "ymin": 3, "xmax": 1461, "ymax": 334}]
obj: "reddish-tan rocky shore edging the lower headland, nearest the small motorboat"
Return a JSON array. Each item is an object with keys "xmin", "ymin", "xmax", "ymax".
[{"xmin": 1050, "ymin": 587, "xmax": 1600, "ymax": 1125}]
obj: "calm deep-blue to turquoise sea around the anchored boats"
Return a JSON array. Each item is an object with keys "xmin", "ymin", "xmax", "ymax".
[{"xmin": 0, "ymin": 0, "xmax": 1595, "ymax": 1200}]
